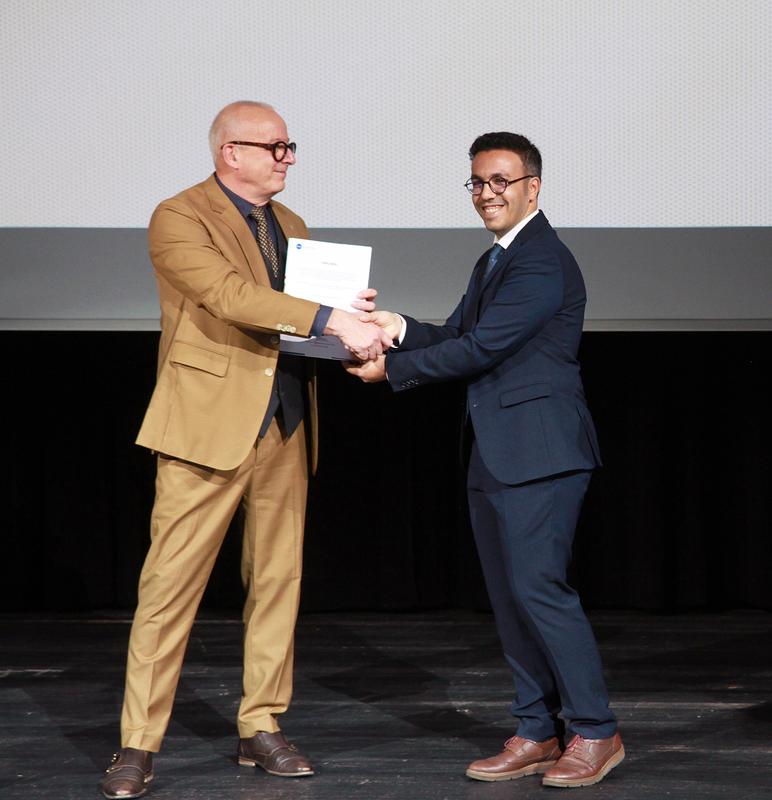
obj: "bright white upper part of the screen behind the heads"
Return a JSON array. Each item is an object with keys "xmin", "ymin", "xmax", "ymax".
[{"xmin": 0, "ymin": 0, "xmax": 772, "ymax": 229}]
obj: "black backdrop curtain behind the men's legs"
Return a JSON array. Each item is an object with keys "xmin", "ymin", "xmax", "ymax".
[{"xmin": 0, "ymin": 332, "xmax": 772, "ymax": 611}]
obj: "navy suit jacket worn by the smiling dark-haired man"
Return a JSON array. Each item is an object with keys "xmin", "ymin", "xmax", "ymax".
[{"xmin": 386, "ymin": 212, "xmax": 600, "ymax": 485}]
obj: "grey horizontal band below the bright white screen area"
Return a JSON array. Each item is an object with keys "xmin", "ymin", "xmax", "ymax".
[{"xmin": 0, "ymin": 228, "xmax": 772, "ymax": 331}]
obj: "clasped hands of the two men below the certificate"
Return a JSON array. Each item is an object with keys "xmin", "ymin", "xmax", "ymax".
[{"xmin": 324, "ymin": 289, "xmax": 402, "ymax": 383}]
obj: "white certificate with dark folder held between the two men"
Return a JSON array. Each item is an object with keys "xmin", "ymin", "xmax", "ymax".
[{"xmin": 281, "ymin": 237, "xmax": 373, "ymax": 361}]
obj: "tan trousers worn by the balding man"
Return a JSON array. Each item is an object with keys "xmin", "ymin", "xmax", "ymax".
[{"xmin": 121, "ymin": 422, "xmax": 308, "ymax": 752}]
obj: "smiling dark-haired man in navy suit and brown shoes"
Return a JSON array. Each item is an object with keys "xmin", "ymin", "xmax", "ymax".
[{"xmin": 348, "ymin": 133, "xmax": 624, "ymax": 787}]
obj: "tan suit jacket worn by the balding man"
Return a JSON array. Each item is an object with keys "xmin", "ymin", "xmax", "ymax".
[{"xmin": 137, "ymin": 176, "xmax": 319, "ymax": 470}]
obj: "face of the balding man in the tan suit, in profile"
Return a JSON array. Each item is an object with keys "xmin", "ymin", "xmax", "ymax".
[{"xmin": 215, "ymin": 106, "xmax": 295, "ymax": 205}]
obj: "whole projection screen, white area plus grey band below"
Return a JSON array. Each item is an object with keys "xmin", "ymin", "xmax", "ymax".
[{"xmin": 0, "ymin": 0, "xmax": 772, "ymax": 330}]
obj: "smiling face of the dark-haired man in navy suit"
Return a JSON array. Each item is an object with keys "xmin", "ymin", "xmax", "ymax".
[{"xmin": 472, "ymin": 150, "xmax": 541, "ymax": 238}]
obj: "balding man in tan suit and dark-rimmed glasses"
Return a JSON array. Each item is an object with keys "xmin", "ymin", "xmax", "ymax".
[{"xmin": 100, "ymin": 102, "xmax": 391, "ymax": 798}]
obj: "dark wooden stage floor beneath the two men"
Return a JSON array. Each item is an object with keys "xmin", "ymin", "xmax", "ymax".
[{"xmin": 0, "ymin": 612, "xmax": 772, "ymax": 800}]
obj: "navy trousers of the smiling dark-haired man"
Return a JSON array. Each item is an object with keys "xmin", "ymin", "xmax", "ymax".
[{"xmin": 467, "ymin": 442, "xmax": 617, "ymax": 741}]
